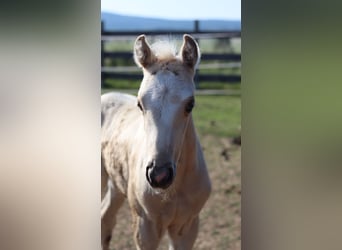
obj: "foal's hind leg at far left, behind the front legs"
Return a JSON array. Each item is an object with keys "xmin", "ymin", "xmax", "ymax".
[{"xmin": 101, "ymin": 179, "xmax": 125, "ymax": 250}]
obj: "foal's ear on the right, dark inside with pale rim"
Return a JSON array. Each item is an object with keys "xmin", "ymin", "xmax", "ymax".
[{"xmin": 181, "ymin": 34, "xmax": 201, "ymax": 69}]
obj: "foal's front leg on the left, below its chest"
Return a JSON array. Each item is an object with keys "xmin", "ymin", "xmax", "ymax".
[{"xmin": 132, "ymin": 212, "xmax": 163, "ymax": 250}]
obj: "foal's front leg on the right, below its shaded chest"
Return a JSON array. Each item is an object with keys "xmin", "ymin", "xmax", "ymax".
[{"xmin": 168, "ymin": 216, "xmax": 199, "ymax": 250}]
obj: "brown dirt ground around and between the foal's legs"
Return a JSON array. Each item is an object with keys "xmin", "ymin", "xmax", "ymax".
[{"xmin": 111, "ymin": 136, "xmax": 241, "ymax": 250}]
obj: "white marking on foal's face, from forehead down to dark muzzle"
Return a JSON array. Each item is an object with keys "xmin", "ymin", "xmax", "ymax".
[{"xmin": 138, "ymin": 70, "xmax": 194, "ymax": 165}]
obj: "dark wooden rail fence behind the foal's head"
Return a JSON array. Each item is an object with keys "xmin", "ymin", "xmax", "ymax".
[{"xmin": 101, "ymin": 21, "xmax": 241, "ymax": 87}]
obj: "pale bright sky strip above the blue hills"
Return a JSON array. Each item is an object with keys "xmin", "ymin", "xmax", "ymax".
[{"xmin": 101, "ymin": 0, "xmax": 241, "ymax": 20}]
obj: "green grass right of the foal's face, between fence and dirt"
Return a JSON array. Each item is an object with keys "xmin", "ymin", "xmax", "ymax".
[{"xmin": 193, "ymin": 95, "xmax": 241, "ymax": 137}]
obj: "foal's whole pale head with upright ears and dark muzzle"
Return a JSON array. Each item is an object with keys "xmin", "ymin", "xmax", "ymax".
[{"xmin": 134, "ymin": 35, "xmax": 200, "ymax": 189}]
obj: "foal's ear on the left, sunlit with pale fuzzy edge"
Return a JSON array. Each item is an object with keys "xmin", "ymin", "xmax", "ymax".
[{"xmin": 134, "ymin": 35, "xmax": 156, "ymax": 68}]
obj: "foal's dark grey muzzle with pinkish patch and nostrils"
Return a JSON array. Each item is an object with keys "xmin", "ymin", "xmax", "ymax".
[{"xmin": 146, "ymin": 163, "xmax": 174, "ymax": 189}]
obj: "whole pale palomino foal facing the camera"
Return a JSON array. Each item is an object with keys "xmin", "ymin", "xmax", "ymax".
[{"xmin": 101, "ymin": 35, "xmax": 211, "ymax": 249}]
